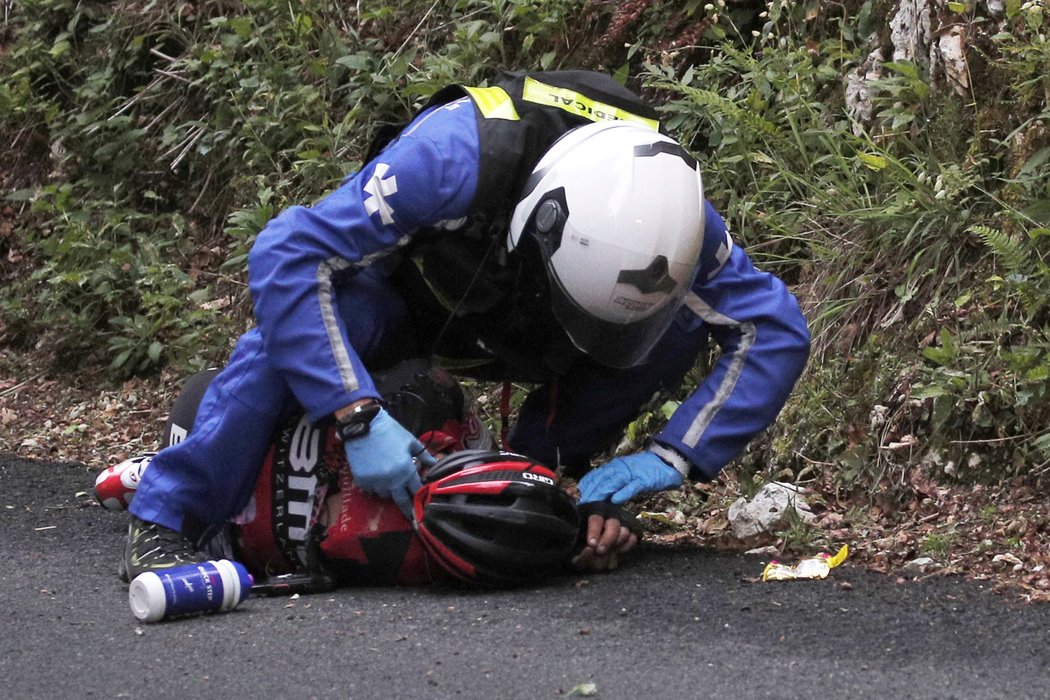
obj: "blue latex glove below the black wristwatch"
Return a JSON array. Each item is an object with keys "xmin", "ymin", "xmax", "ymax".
[{"xmin": 342, "ymin": 408, "xmax": 437, "ymax": 519}]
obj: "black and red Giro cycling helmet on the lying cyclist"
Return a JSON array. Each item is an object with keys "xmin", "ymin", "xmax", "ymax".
[{"xmin": 414, "ymin": 450, "xmax": 580, "ymax": 586}]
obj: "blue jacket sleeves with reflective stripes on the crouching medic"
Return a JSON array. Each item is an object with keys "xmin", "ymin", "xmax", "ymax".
[{"xmin": 249, "ymin": 91, "xmax": 809, "ymax": 478}]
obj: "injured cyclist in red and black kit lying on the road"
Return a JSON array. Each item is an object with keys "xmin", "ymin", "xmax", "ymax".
[{"xmin": 96, "ymin": 361, "xmax": 641, "ymax": 593}]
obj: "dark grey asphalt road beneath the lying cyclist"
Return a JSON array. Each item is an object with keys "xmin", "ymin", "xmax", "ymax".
[{"xmin": 0, "ymin": 454, "xmax": 1050, "ymax": 699}]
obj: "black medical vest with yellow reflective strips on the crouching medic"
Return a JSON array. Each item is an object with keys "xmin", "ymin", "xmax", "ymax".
[{"xmin": 386, "ymin": 70, "xmax": 662, "ymax": 382}]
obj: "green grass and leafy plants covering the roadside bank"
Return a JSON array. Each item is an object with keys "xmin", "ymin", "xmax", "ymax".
[{"xmin": 0, "ymin": 0, "xmax": 1050, "ymax": 486}]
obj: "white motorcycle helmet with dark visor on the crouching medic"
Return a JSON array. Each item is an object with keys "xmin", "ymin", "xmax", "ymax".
[{"xmin": 507, "ymin": 121, "xmax": 705, "ymax": 368}]
